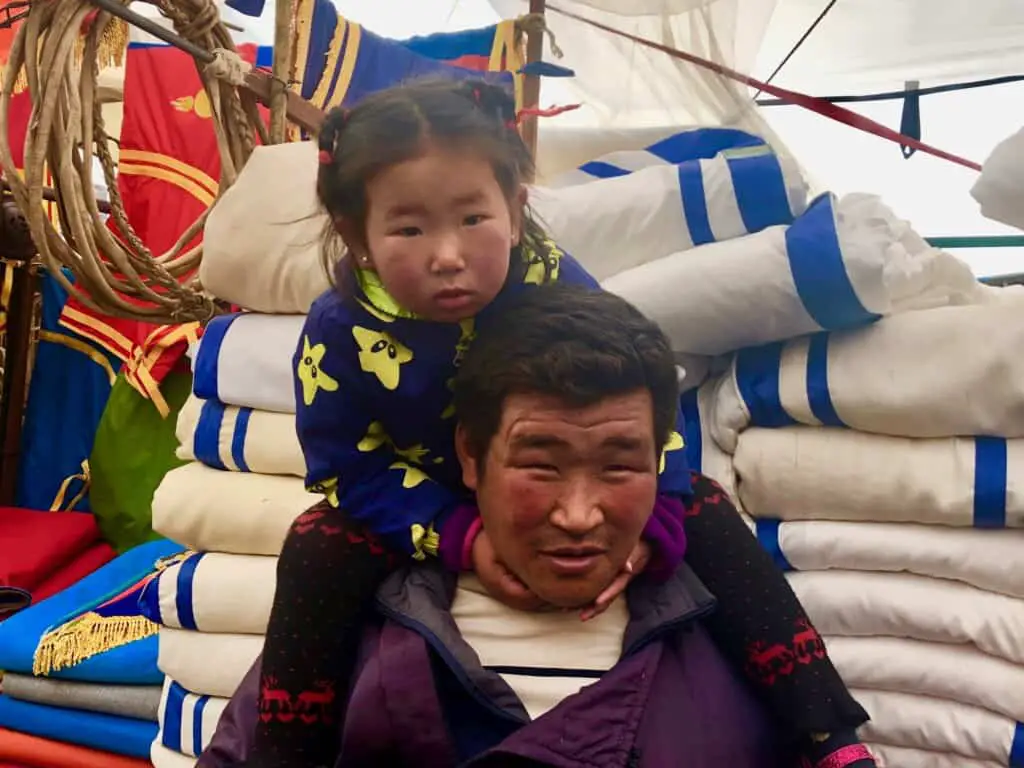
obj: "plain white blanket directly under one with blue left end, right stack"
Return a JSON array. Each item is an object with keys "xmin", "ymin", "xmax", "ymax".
[{"xmin": 787, "ymin": 570, "xmax": 1024, "ymax": 665}]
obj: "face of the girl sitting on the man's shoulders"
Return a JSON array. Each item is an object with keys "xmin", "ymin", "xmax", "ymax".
[{"xmin": 354, "ymin": 145, "xmax": 526, "ymax": 323}]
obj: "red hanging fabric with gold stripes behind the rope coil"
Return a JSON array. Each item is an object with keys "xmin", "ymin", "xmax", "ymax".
[{"xmin": 60, "ymin": 45, "xmax": 264, "ymax": 414}]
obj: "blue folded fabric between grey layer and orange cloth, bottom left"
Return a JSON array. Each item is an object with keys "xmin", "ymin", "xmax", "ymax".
[{"xmin": 0, "ymin": 694, "xmax": 159, "ymax": 757}]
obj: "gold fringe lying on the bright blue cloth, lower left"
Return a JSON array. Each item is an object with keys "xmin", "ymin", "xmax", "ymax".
[{"xmin": 32, "ymin": 612, "xmax": 159, "ymax": 677}]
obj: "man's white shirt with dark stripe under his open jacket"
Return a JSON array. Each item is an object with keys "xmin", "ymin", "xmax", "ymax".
[{"xmin": 452, "ymin": 573, "xmax": 629, "ymax": 720}]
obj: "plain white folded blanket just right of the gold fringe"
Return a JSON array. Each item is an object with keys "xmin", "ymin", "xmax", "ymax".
[{"xmin": 157, "ymin": 627, "xmax": 263, "ymax": 698}]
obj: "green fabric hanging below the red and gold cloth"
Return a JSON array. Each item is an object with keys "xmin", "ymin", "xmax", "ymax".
[{"xmin": 89, "ymin": 373, "xmax": 191, "ymax": 552}]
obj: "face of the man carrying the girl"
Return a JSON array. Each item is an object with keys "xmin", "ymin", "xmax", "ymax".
[{"xmin": 457, "ymin": 390, "xmax": 657, "ymax": 608}]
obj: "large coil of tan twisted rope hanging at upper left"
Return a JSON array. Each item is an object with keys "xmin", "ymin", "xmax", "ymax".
[{"xmin": 0, "ymin": 0, "xmax": 267, "ymax": 324}]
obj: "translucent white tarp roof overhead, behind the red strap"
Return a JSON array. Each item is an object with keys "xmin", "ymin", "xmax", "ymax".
[{"xmin": 140, "ymin": 0, "xmax": 1024, "ymax": 274}]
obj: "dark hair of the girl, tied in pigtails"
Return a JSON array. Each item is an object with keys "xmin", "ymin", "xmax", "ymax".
[{"xmin": 316, "ymin": 78, "xmax": 551, "ymax": 297}]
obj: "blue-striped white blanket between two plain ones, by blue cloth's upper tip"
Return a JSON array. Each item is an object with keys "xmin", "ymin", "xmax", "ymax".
[{"xmin": 139, "ymin": 552, "xmax": 278, "ymax": 635}]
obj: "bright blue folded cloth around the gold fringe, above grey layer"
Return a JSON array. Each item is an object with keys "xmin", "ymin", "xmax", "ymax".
[{"xmin": 0, "ymin": 539, "xmax": 184, "ymax": 685}]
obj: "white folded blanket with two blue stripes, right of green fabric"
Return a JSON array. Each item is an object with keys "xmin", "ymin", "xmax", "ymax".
[{"xmin": 175, "ymin": 395, "xmax": 306, "ymax": 477}]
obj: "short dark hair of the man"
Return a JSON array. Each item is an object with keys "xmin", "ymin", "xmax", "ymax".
[{"xmin": 455, "ymin": 283, "xmax": 679, "ymax": 464}]
